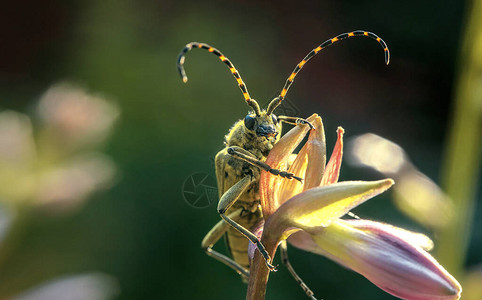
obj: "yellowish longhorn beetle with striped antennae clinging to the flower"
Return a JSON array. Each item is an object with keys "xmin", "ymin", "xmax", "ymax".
[{"xmin": 177, "ymin": 30, "xmax": 390, "ymax": 299}]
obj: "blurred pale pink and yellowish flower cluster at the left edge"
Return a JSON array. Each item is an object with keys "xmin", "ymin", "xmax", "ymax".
[{"xmin": 0, "ymin": 83, "xmax": 119, "ymax": 212}]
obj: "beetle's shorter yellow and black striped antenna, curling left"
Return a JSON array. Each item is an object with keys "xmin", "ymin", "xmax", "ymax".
[{"xmin": 177, "ymin": 42, "xmax": 261, "ymax": 116}]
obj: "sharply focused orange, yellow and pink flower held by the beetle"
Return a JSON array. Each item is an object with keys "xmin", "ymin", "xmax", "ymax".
[{"xmin": 247, "ymin": 115, "xmax": 461, "ymax": 299}]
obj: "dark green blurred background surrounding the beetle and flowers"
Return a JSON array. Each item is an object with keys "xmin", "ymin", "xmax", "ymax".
[{"xmin": 0, "ymin": 0, "xmax": 482, "ymax": 299}]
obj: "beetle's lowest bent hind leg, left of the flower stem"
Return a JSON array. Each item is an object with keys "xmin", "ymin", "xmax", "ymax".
[{"xmin": 201, "ymin": 209, "xmax": 249, "ymax": 281}]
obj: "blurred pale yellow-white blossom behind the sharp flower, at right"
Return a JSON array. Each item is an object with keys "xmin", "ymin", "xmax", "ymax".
[{"xmin": 348, "ymin": 133, "xmax": 454, "ymax": 229}]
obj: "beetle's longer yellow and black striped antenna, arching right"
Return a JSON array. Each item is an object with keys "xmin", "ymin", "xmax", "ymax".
[{"xmin": 266, "ymin": 30, "xmax": 390, "ymax": 114}]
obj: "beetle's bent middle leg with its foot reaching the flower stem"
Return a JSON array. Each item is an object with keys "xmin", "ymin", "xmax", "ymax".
[{"xmin": 218, "ymin": 175, "xmax": 276, "ymax": 271}]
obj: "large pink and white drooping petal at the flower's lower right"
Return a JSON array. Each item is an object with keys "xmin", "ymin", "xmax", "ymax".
[{"xmin": 289, "ymin": 220, "xmax": 462, "ymax": 300}]
